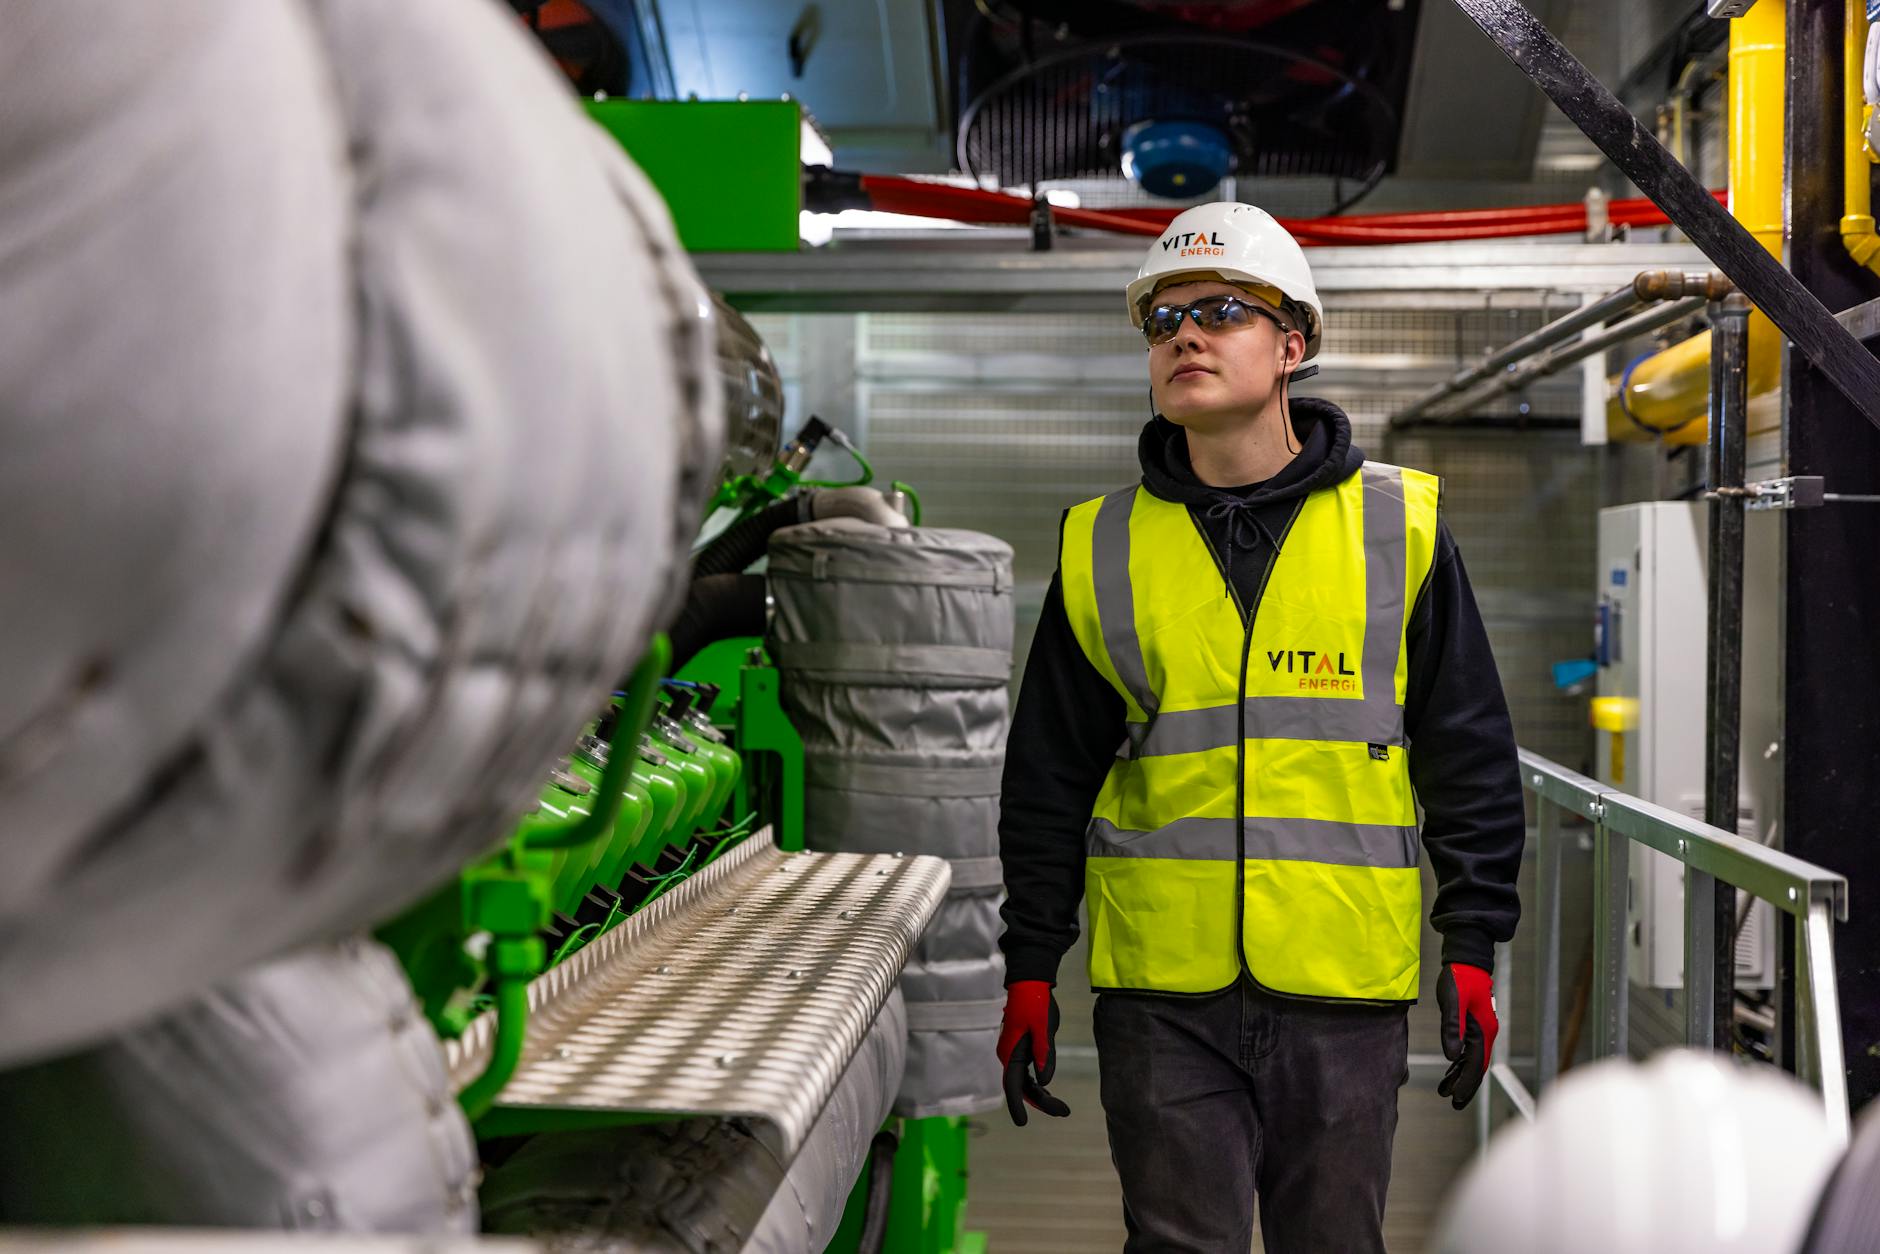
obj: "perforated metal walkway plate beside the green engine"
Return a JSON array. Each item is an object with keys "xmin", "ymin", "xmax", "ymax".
[{"xmin": 446, "ymin": 831, "xmax": 949, "ymax": 1158}]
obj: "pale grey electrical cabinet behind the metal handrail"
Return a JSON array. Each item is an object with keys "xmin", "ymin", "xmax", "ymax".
[{"xmin": 1592, "ymin": 502, "xmax": 1782, "ymax": 989}]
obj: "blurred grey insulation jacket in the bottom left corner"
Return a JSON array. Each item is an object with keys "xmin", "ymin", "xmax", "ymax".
[{"xmin": 0, "ymin": 940, "xmax": 478, "ymax": 1235}]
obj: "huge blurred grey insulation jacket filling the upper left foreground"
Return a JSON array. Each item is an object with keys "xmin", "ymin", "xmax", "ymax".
[{"xmin": 0, "ymin": 0, "xmax": 722, "ymax": 1062}]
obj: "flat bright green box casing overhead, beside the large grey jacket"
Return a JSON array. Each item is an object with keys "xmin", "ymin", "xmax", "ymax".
[{"xmin": 585, "ymin": 100, "xmax": 803, "ymax": 252}]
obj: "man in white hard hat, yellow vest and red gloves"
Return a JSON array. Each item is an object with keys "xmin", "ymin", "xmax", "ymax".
[{"xmin": 998, "ymin": 203, "xmax": 1525, "ymax": 1254}]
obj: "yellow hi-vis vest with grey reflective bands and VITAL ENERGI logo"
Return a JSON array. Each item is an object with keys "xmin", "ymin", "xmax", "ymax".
[{"xmin": 1058, "ymin": 462, "xmax": 1440, "ymax": 1002}]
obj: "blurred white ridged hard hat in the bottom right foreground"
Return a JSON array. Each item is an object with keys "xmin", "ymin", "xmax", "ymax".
[{"xmin": 1431, "ymin": 1049, "xmax": 1841, "ymax": 1254}]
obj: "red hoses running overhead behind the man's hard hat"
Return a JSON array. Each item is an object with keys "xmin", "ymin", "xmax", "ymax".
[{"xmin": 861, "ymin": 175, "xmax": 1726, "ymax": 246}]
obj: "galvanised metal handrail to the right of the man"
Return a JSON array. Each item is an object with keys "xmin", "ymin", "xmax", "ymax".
[{"xmin": 1476, "ymin": 748, "xmax": 1848, "ymax": 1149}]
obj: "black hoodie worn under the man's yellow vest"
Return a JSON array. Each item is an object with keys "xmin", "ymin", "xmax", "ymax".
[{"xmin": 998, "ymin": 397, "xmax": 1527, "ymax": 983}]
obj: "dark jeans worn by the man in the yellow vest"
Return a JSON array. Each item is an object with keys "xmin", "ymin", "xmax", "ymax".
[{"xmin": 1096, "ymin": 981, "xmax": 1410, "ymax": 1254}]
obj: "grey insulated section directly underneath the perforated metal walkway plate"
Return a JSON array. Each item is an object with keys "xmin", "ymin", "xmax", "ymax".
[{"xmin": 483, "ymin": 993, "xmax": 908, "ymax": 1254}]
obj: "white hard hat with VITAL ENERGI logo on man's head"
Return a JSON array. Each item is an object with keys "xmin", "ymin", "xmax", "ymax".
[{"xmin": 1128, "ymin": 201, "xmax": 1325, "ymax": 361}]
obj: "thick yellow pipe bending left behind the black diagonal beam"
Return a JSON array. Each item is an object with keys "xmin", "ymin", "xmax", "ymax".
[{"xmin": 1606, "ymin": 0, "xmax": 1782, "ymax": 444}]
